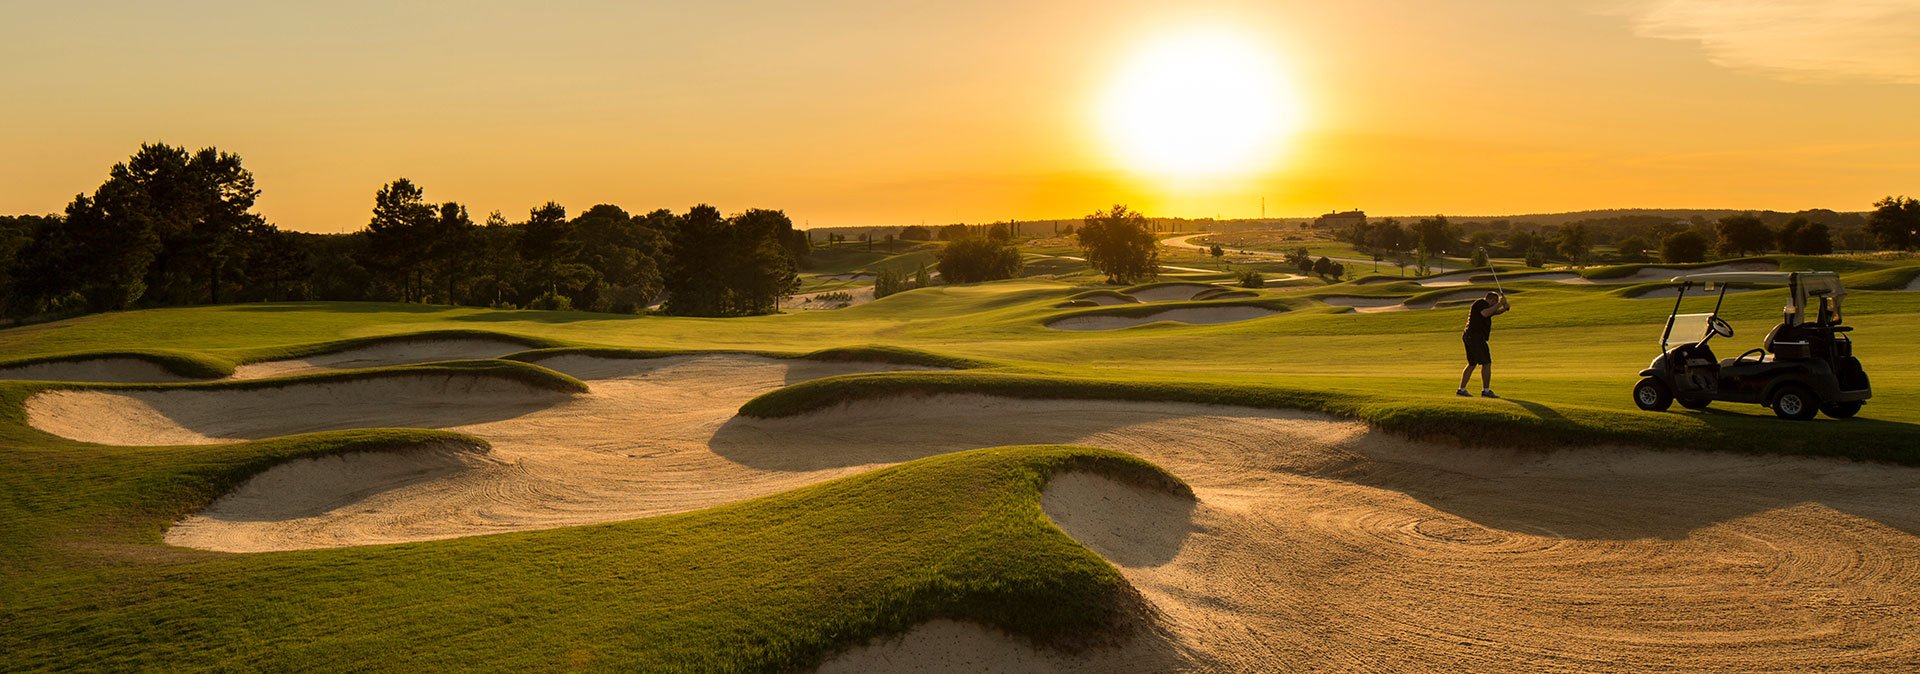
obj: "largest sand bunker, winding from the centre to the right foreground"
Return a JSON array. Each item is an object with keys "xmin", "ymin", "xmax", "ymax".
[{"xmin": 29, "ymin": 355, "xmax": 1920, "ymax": 672}]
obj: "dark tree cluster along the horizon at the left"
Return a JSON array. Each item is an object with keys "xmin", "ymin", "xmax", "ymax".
[{"xmin": 0, "ymin": 144, "xmax": 810, "ymax": 319}]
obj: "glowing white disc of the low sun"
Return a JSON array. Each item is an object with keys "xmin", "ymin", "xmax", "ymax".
[{"xmin": 1098, "ymin": 31, "xmax": 1300, "ymax": 179}]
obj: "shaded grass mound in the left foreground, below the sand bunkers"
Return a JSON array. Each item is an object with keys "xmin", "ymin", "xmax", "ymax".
[{"xmin": 0, "ymin": 441, "xmax": 1190, "ymax": 670}]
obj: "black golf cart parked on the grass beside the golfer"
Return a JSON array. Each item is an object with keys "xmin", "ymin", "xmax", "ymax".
[{"xmin": 1634, "ymin": 271, "xmax": 1874, "ymax": 421}]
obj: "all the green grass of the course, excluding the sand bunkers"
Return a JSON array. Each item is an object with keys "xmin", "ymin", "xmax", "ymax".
[{"xmin": 0, "ymin": 257, "xmax": 1920, "ymax": 670}]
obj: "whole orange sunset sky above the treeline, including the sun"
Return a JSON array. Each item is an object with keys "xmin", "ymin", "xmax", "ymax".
[{"xmin": 0, "ymin": 0, "xmax": 1920, "ymax": 230}]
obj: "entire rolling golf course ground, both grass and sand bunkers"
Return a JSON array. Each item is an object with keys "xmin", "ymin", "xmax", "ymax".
[{"xmin": 0, "ymin": 255, "xmax": 1920, "ymax": 672}]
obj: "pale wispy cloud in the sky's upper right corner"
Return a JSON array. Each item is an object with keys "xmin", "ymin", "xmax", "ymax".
[{"xmin": 1619, "ymin": 0, "xmax": 1920, "ymax": 84}]
